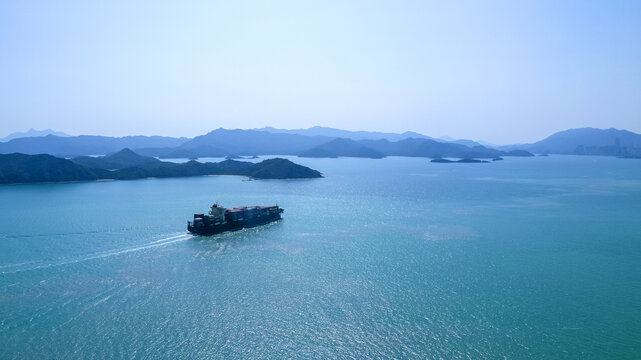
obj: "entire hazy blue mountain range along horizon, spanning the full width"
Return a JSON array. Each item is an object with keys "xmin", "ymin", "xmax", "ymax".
[{"xmin": 0, "ymin": 127, "xmax": 641, "ymax": 160}]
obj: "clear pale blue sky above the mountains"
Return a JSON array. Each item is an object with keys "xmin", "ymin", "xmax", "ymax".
[{"xmin": 0, "ymin": 0, "xmax": 641, "ymax": 144}]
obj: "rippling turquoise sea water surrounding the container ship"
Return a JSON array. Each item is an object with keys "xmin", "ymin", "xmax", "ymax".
[{"xmin": 0, "ymin": 156, "xmax": 641, "ymax": 359}]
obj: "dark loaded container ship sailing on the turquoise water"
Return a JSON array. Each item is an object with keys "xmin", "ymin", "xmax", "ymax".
[{"xmin": 187, "ymin": 203, "xmax": 285, "ymax": 235}]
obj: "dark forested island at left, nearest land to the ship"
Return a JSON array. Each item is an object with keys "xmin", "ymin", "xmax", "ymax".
[{"xmin": 0, "ymin": 149, "xmax": 322, "ymax": 184}]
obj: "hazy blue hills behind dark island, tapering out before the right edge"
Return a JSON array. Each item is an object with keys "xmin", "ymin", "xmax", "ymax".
[{"xmin": 0, "ymin": 129, "xmax": 520, "ymax": 162}]
